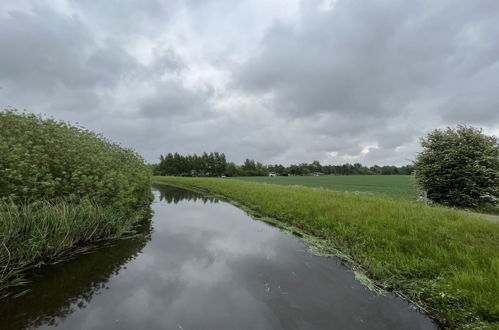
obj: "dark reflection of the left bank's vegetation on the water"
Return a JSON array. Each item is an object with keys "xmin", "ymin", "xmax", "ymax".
[{"xmin": 0, "ymin": 214, "xmax": 152, "ymax": 329}]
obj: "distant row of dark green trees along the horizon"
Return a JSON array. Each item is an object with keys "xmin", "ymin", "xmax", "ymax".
[{"xmin": 151, "ymin": 152, "xmax": 414, "ymax": 177}]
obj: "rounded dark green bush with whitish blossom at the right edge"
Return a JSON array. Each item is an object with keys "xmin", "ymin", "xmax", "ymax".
[{"xmin": 414, "ymin": 126, "xmax": 499, "ymax": 208}]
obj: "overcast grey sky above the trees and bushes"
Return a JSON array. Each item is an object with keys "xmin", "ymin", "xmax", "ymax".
[{"xmin": 0, "ymin": 0, "xmax": 499, "ymax": 165}]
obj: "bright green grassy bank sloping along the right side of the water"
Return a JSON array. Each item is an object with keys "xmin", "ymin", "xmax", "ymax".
[{"xmin": 154, "ymin": 177, "xmax": 499, "ymax": 328}]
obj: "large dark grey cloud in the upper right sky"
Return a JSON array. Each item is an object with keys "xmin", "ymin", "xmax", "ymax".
[{"xmin": 235, "ymin": 0, "xmax": 499, "ymax": 124}]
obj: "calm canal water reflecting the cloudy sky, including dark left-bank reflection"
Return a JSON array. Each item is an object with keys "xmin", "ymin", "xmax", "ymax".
[{"xmin": 0, "ymin": 188, "xmax": 435, "ymax": 330}]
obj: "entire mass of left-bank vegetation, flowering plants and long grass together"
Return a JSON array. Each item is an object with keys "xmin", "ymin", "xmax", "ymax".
[{"xmin": 0, "ymin": 110, "xmax": 152, "ymax": 298}]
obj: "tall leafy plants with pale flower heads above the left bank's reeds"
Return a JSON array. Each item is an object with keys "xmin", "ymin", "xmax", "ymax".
[{"xmin": 0, "ymin": 110, "xmax": 151, "ymax": 213}]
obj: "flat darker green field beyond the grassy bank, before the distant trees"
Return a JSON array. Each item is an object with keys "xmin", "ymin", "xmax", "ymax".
[{"xmin": 234, "ymin": 175, "xmax": 419, "ymax": 200}]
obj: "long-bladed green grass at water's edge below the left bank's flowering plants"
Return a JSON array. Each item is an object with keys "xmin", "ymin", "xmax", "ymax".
[{"xmin": 0, "ymin": 199, "xmax": 145, "ymax": 297}]
